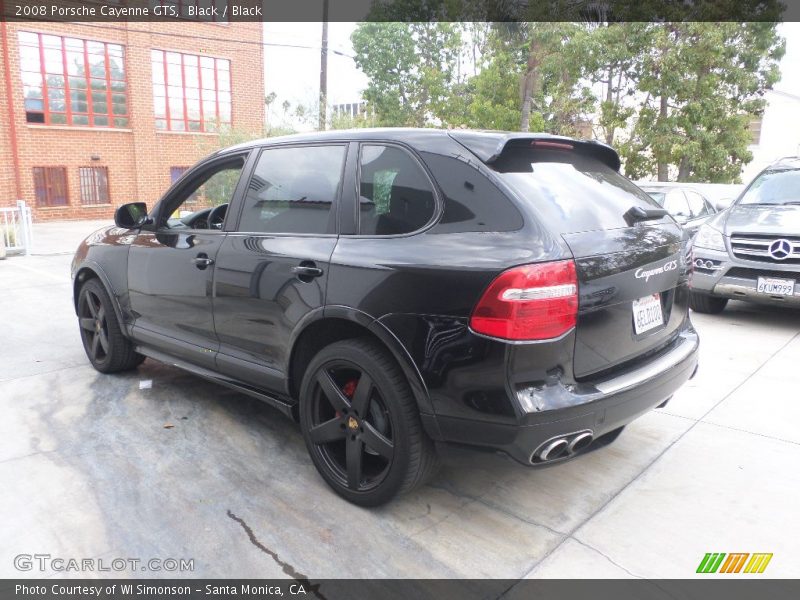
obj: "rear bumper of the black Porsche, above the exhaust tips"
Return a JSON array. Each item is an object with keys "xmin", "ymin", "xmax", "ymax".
[{"xmin": 436, "ymin": 328, "xmax": 699, "ymax": 465}]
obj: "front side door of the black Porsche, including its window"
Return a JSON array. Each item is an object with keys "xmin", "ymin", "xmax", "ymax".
[{"xmin": 128, "ymin": 154, "xmax": 247, "ymax": 368}]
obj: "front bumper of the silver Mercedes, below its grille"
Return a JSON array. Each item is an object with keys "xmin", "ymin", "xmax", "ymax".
[{"xmin": 692, "ymin": 248, "xmax": 800, "ymax": 307}]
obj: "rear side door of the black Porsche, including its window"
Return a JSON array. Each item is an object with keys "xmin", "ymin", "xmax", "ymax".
[{"xmin": 213, "ymin": 143, "xmax": 355, "ymax": 392}]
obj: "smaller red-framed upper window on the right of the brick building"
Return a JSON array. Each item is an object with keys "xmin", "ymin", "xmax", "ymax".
[{"xmin": 151, "ymin": 50, "xmax": 231, "ymax": 132}]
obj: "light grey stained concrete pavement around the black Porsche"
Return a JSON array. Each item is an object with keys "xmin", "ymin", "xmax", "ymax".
[{"xmin": 0, "ymin": 222, "xmax": 800, "ymax": 579}]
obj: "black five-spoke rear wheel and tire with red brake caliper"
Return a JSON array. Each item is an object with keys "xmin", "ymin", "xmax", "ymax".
[{"xmin": 300, "ymin": 339, "xmax": 438, "ymax": 506}]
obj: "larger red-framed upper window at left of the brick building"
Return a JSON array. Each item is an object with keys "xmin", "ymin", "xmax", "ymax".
[{"xmin": 19, "ymin": 31, "xmax": 128, "ymax": 127}]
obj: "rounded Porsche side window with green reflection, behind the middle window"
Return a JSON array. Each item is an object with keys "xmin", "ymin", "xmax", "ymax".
[{"xmin": 359, "ymin": 144, "xmax": 436, "ymax": 235}]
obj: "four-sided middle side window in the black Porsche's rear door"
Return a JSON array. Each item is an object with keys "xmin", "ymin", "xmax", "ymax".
[{"xmin": 239, "ymin": 145, "xmax": 346, "ymax": 233}]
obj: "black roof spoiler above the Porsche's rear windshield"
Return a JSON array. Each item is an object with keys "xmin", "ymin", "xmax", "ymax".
[{"xmin": 448, "ymin": 131, "xmax": 620, "ymax": 171}]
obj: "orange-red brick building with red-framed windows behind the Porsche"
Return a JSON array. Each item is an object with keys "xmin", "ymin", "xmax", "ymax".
[{"xmin": 0, "ymin": 21, "xmax": 264, "ymax": 221}]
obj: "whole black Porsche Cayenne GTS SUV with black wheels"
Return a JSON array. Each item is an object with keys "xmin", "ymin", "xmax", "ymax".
[{"xmin": 72, "ymin": 129, "xmax": 698, "ymax": 505}]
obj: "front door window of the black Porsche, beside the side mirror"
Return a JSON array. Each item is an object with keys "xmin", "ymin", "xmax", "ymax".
[{"xmin": 162, "ymin": 156, "xmax": 244, "ymax": 229}]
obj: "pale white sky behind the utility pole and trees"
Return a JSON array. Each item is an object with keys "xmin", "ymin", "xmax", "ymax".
[{"xmin": 264, "ymin": 23, "xmax": 800, "ymax": 129}]
